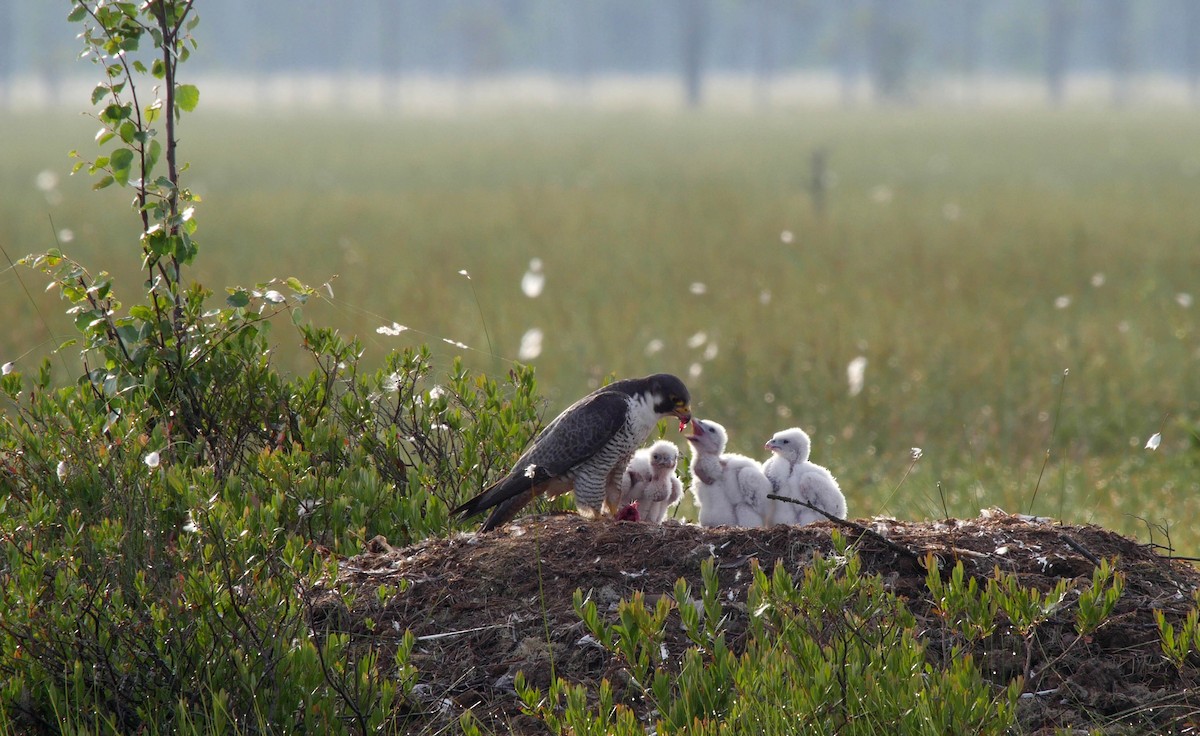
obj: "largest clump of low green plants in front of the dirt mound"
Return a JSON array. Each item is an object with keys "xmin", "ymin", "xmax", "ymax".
[{"xmin": 518, "ymin": 539, "xmax": 1021, "ymax": 735}]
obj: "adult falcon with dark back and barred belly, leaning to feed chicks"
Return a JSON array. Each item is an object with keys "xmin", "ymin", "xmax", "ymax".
[{"xmin": 454, "ymin": 373, "xmax": 691, "ymax": 532}]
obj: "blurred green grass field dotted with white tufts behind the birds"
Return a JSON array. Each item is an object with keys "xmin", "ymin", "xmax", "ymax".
[{"xmin": 0, "ymin": 109, "xmax": 1200, "ymax": 547}]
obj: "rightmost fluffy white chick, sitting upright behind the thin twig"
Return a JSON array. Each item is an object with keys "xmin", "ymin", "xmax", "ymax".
[{"xmin": 762, "ymin": 426, "xmax": 846, "ymax": 525}]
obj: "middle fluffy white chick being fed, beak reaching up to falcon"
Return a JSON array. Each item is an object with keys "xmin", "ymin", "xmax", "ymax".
[{"xmin": 688, "ymin": 419, "xmax": 770, "ymax": 527}]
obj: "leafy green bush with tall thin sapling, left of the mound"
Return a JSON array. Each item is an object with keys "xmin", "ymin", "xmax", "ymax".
[{"xmin": 0, "ymin": 0, "xmax": 538, "ymax": 734}]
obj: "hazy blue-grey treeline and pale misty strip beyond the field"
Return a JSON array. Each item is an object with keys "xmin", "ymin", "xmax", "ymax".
[{"xmin": 7, "ymin": 0, "xmax": 1200, "ymax": 112}]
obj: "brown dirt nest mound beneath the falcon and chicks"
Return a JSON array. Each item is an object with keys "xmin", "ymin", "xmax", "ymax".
[{"xmin": 310, "ymin": 514, "xmax": 1200, "ymax": 732}]
